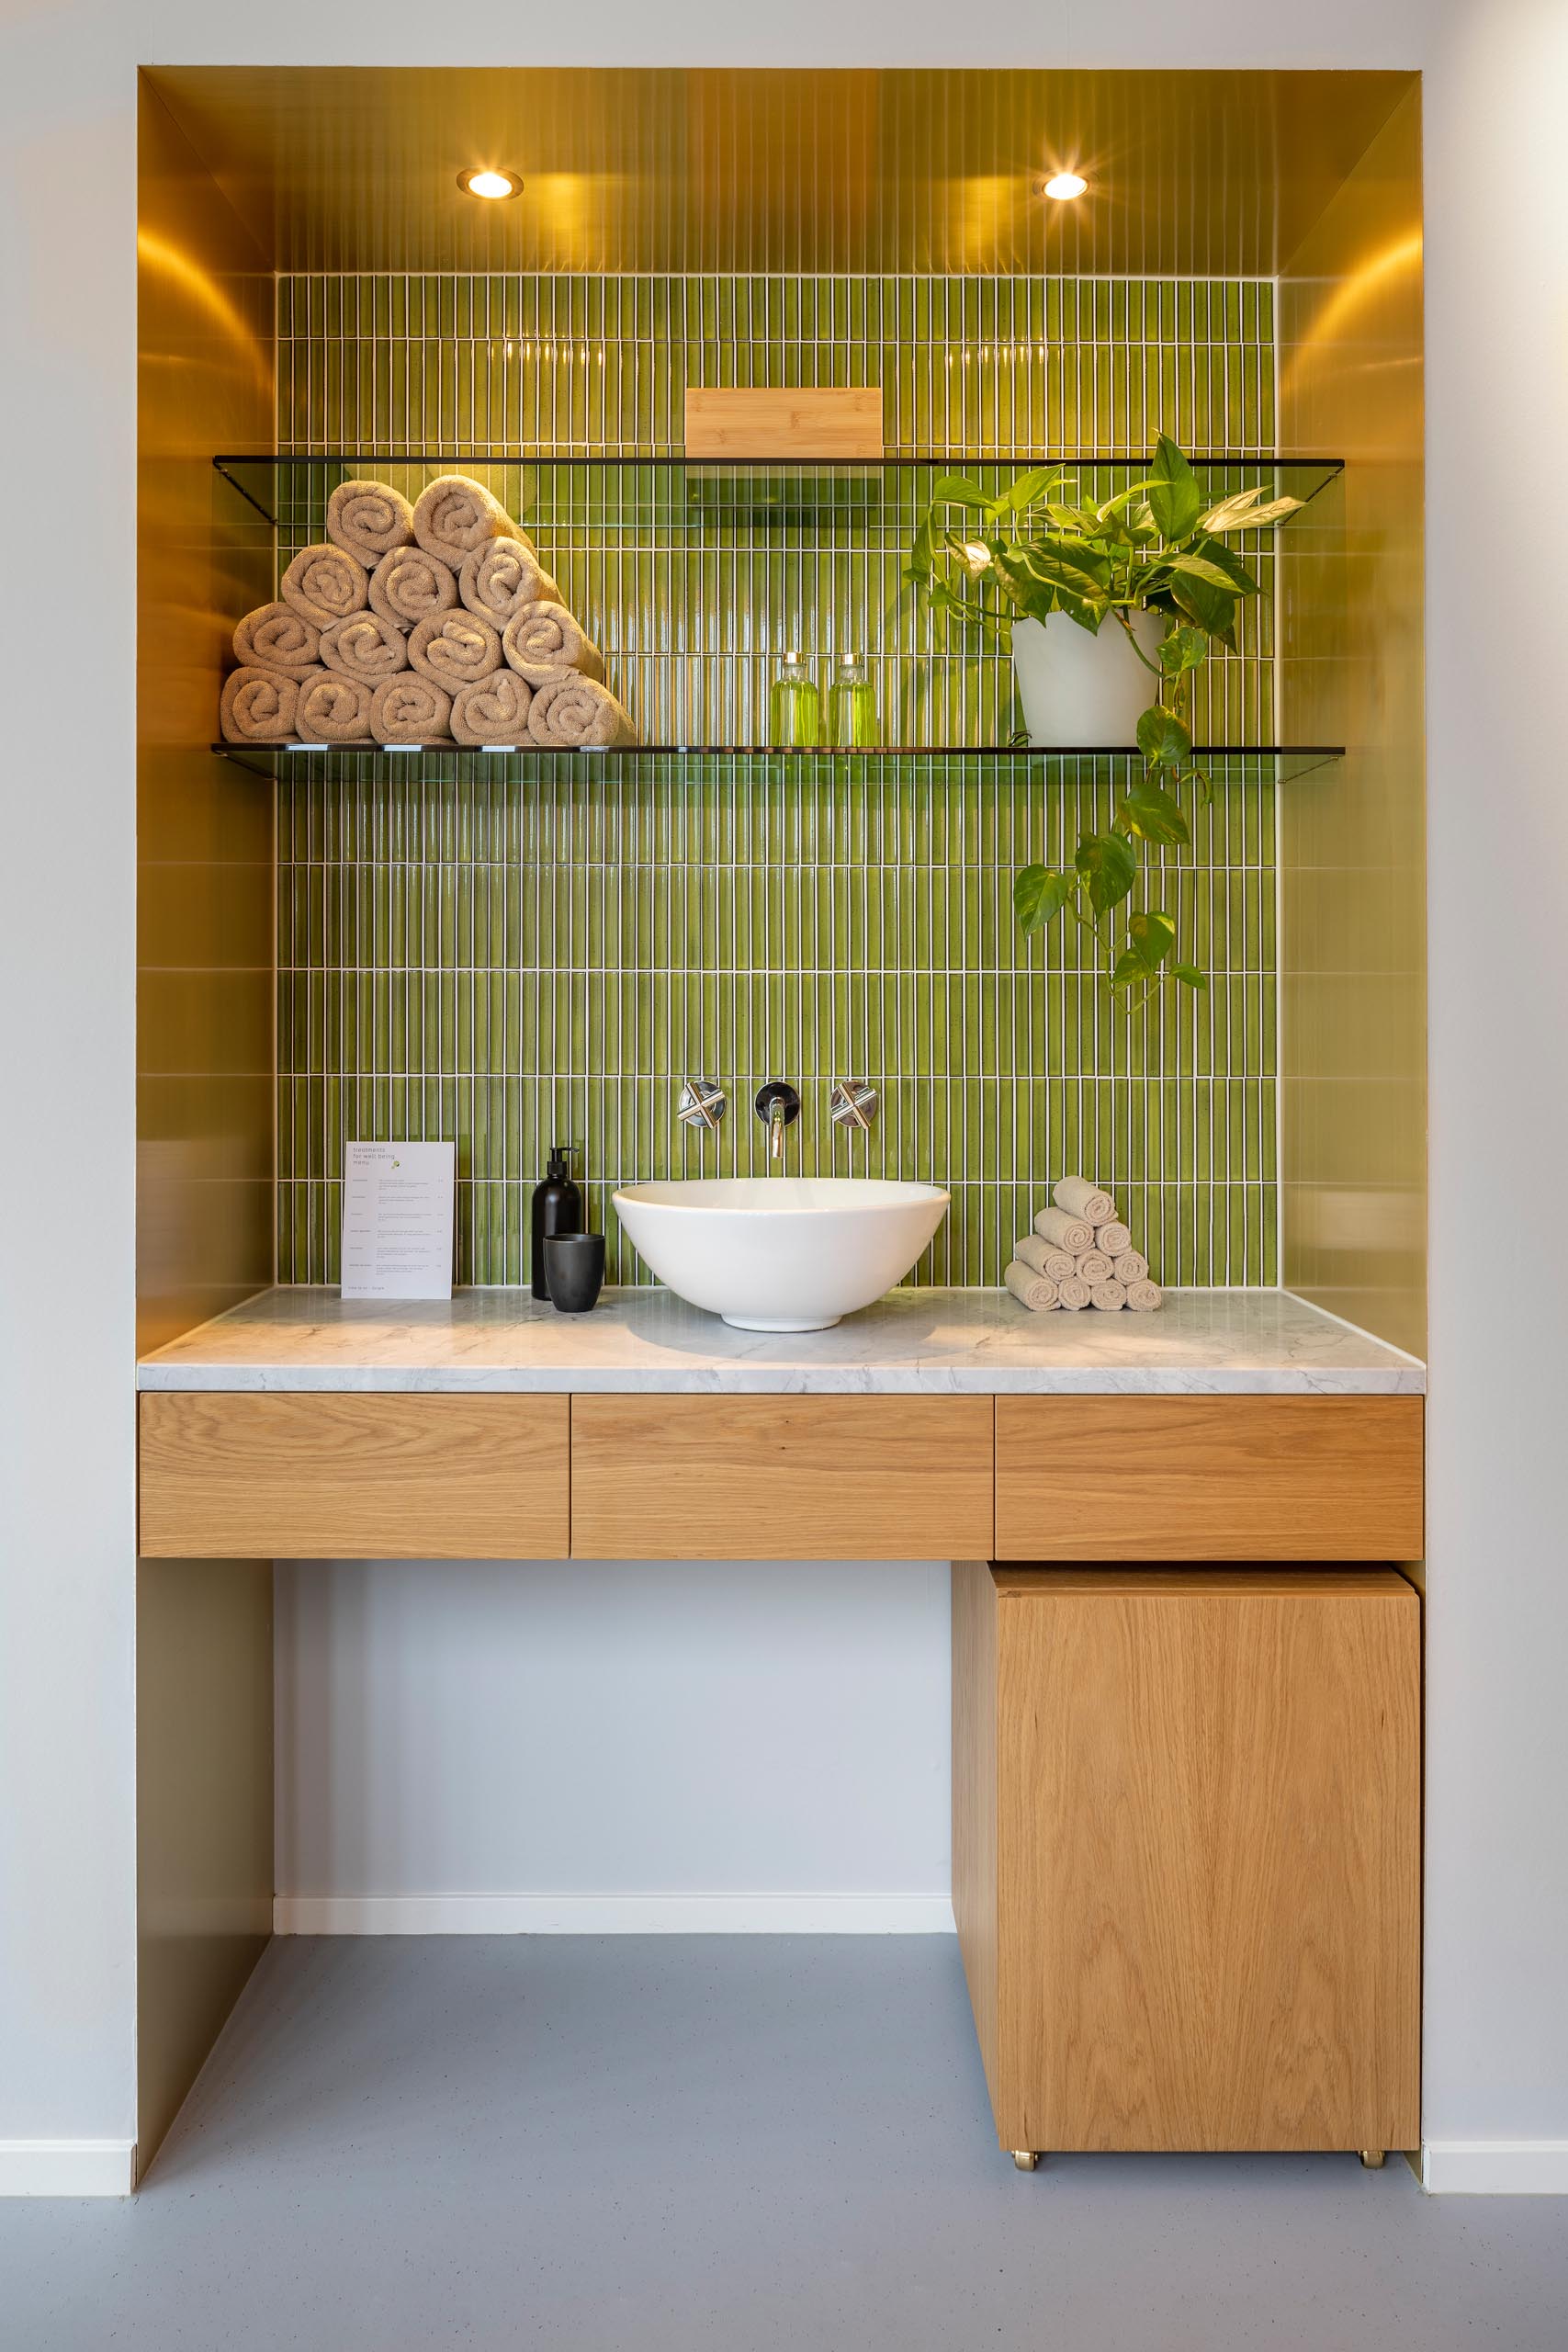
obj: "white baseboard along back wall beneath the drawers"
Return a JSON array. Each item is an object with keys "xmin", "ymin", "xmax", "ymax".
[{"xmin": 273, "ymin": 1894, "xmax": 952, "ymax": 1936}]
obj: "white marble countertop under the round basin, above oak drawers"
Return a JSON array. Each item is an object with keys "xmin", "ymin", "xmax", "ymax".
[{"xmin": 136, "ymin": 1289, "xmax": 1427, "ymax": 1397}]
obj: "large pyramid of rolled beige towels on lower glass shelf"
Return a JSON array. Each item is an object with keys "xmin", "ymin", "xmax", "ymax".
[{"xmin": 221, "ymin": 473, "xmax": 637, "ymax": 751}]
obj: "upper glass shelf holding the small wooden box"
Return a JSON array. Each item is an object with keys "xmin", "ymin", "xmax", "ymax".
[{"xmin": 211, "ymin": 449, "xmax": 1345, "ymax": 529}]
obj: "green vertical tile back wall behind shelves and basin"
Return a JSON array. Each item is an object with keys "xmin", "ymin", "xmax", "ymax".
[{"xmin": 277, "ymin": 276, "xmax": 1277, "ymax": 1282}]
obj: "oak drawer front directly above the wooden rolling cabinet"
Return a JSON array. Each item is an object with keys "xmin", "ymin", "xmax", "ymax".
[{"xmin": 992, "ymin": 1397, "xmax": 1422, "ymax": 1559}]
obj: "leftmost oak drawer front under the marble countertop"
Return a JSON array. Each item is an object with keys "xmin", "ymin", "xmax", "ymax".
[{"xmin": 141, "ymin": 1395, "xmax": 571, "ymax": 1559}]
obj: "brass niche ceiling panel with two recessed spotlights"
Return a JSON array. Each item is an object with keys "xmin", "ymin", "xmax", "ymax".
[{"xmin": 148, "ymin": 66, "xmax": 1416, "ymax": 276}]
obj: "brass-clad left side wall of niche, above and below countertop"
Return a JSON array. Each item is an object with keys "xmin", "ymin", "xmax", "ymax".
[{"xmin": 135, "ymin": 80, "xmax": 275, "ymax": 2171}]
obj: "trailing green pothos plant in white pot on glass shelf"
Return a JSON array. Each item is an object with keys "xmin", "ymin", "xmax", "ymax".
[{"xmin": 903, "ymin": 433, "xmax": 1303, "ymax": 1009}]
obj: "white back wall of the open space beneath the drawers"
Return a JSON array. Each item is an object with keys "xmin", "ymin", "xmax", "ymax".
[{"xmin": 275, "ymin": 1562, "xmax": 952, "ymax": 1928}]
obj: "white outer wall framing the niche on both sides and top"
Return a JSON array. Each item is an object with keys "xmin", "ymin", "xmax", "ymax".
[{"xmin": 0, "ymin": 0, "xmax": 1568, "ymax": 2188}]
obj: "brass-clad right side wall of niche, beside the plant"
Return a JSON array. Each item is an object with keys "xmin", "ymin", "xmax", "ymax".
[{"xmin": 1279, "ymin": 89, "xmax": 1427, "ymax": 1355}]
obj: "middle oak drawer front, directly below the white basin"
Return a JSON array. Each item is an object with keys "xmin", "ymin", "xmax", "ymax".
[{"xmin": 571, "ymin": 1397, "xmax": 992, "ymax": 1559}]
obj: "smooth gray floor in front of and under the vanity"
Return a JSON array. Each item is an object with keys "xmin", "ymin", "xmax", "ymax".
[{"xmin": 0, "ymin": 1936, "xmax": 1568, "ymax": 2352}]
